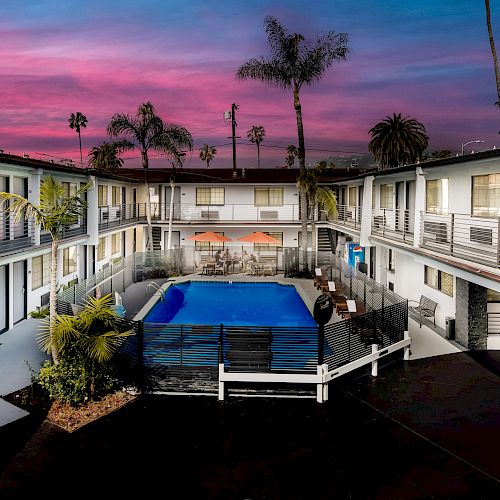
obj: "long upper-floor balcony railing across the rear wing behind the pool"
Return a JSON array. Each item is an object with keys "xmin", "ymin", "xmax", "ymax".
[{"xmin": 151, "ymin": 203, "xmax": 300, "ymax": 223}]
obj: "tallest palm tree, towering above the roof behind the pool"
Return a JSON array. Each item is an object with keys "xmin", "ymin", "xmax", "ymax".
[{"xmin": 236, "ymin": 16, "xmax": 349, "ymax": 271}]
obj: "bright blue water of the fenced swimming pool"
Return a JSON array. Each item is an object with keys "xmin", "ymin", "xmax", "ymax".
[{"xmin": 144, "ymin": 282, "xmax": 316, "ymax": 326}]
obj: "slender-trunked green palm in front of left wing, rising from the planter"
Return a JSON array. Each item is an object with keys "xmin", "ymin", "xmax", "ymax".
[{"xmin": 0, "ymin": 176, "xmax": 92, "ymax": 363}]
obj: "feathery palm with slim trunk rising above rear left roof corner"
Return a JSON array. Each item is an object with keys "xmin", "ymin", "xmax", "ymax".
[{"xmin": 108, "ymin": 102, "xmax": 193, "ymax": 251}]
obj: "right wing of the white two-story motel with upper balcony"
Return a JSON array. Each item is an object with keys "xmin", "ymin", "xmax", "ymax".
[{"xmin": 321, "ymin": 150, "xmax": 500, "ymax": 349}]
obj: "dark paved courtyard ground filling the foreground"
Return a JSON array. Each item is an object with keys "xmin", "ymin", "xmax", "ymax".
[{"xmin": 0, "ymin": 352, "xmax": 500, "ymax": 499}]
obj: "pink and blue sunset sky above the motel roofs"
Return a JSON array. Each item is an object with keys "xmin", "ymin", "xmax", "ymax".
[{"xmin": 0, "ymin": 0, "xmax": 500, "ymax": 168}]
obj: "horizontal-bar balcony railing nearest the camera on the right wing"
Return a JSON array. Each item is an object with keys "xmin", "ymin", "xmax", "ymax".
[{"xmin": 420, "ymin": 212, "xmax": 500, "ymax": 267}]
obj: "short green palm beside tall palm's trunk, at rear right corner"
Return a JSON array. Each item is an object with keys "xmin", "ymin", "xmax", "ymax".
[{"xmin": 297, "ymin": 162, "xmax": 337, "ymax": 255}]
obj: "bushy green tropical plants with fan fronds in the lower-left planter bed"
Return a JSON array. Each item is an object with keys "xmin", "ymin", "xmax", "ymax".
[{"xmin": 38, "ymin": 295, "xmax": 133, "ymax": 405}]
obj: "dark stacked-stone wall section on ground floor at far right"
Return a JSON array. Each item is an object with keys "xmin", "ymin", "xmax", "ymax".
[{"xmin": 455, "ymin": 278, "xmax": 488, "ymax": 350}]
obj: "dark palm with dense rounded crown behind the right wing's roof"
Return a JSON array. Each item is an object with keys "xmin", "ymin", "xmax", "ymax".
[{"xmin": 368, "ymin": 113, "xmax": 429, "ymax": 168}]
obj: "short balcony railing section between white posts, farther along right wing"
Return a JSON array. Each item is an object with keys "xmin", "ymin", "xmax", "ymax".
[{"xmin": 372, "ymin": 208, "xmax": 414, "ymax": 245}]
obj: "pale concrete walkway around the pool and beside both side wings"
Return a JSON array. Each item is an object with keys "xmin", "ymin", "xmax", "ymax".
[{"xmin": 0, "ymin": 274, "xmax": 463, "ymax": 427}]
